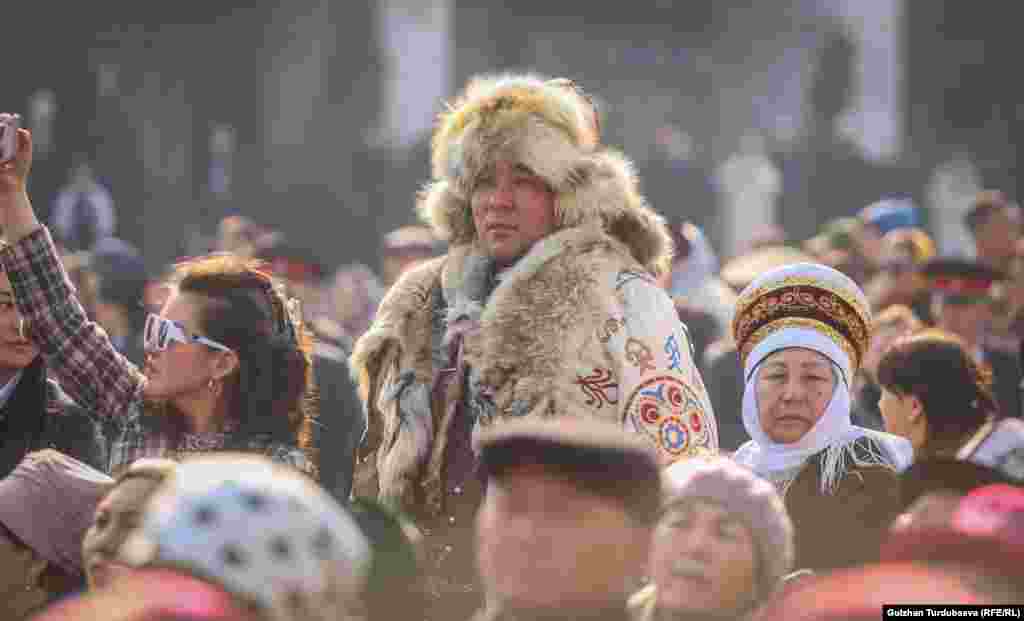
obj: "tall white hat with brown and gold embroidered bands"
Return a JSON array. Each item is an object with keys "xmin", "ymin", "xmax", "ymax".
[{"xmin": 732, "ymin": 263, "xmax": 871, "ymax": 385}]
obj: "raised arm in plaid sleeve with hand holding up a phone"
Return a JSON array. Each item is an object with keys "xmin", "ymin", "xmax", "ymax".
[{"xmin": 0, "ymin": 119, "xmax": 145, "ymax": 417}]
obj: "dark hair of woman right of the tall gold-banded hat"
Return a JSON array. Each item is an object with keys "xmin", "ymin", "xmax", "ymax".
[{"xmin": 878, "ymin": 329, "xmax": 999, "ymax": 453}]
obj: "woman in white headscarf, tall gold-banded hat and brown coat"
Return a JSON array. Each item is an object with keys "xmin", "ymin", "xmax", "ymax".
[{"xmin": 732, "ymin": 263, "xmax": 912, "ymax": 570}]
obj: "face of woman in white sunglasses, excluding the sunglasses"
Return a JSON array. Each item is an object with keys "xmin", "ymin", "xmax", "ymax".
[{"xmin": 144, "ymin": 292, "xmax": 221, "ymax": 400}]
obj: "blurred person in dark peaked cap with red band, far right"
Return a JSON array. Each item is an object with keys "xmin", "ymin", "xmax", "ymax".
[{"xmin": 922, "ymin": 257, "xmax": 1022, "ymax": 416}]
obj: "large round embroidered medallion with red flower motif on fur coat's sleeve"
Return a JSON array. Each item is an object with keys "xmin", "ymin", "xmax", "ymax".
[{"xmin": 625, "ymin": 375, "xmax": 710, "ymax": 457}]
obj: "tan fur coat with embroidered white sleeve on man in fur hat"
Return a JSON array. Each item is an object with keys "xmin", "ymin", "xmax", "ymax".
[{"xmin": 351, "ymin": 225, "xmax": 718, "ymax": 516}]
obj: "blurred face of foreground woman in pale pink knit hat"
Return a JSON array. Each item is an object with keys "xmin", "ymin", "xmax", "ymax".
[{"xmin": 650, "ymin": 500, "xmax": 758, "ymax": 612}]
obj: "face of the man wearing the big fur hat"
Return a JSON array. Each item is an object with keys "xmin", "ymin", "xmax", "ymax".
[{"xmin": 472, "ymin": 160, "xmax": 555, "ymax": 265}]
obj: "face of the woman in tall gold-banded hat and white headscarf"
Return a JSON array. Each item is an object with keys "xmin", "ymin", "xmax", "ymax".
[{"xmin": 756, "ymin": 347, "xmax": 836, "ymax": 444}]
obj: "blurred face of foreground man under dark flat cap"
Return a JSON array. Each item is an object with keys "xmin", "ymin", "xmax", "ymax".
[{"xmin": 477, "ymin": 466, "xmax": 650, "ymax": 608}]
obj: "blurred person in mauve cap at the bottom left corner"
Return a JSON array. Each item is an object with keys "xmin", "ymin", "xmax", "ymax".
[{"xmin": 0, "ymin": 449, "xmax": 114, "ymax": 621}]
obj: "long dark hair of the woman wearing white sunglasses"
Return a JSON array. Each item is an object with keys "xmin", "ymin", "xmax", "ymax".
[{"xmin": 154, "ymin": 253, "xmax": 316, "ymax": 464}]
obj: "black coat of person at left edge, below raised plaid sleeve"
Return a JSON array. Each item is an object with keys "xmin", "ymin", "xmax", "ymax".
[{"xmin": 0, "ymin": 357, "xmax": 108, "ymax": 477}]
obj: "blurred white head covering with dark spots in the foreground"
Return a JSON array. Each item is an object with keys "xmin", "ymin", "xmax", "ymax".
[{"xmin": 118, "ymin": 454, "xmax": 373, "ymax": 621}]
